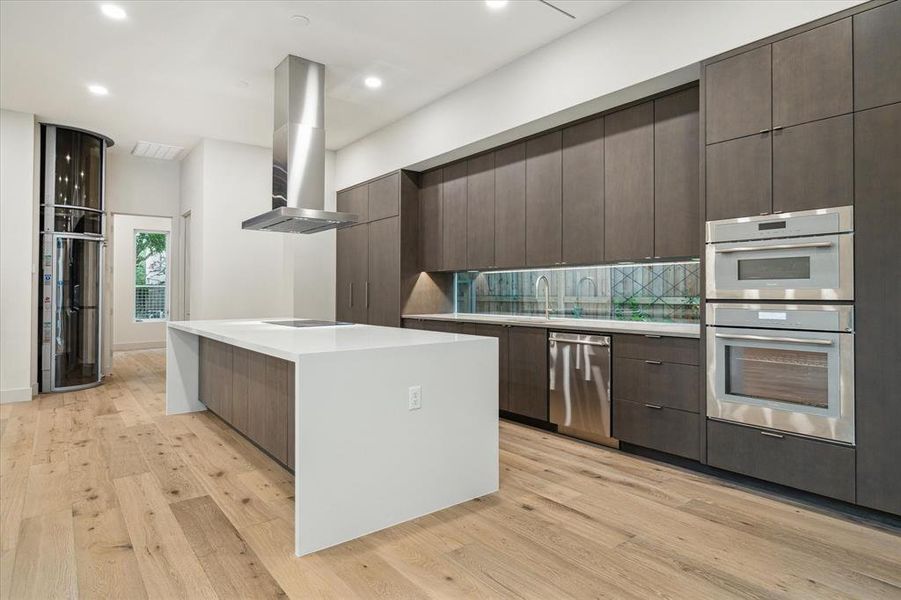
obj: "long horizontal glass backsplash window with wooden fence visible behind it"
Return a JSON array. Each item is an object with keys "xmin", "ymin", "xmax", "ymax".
[{"xmin": 454, "ymin": 261, "xmax": 701, "ymax": 322}]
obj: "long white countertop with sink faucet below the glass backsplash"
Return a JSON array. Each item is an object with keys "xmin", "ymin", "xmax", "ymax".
[{"xmin": 403, "ymin": 313, "xmax": 701, "ymax": 338}]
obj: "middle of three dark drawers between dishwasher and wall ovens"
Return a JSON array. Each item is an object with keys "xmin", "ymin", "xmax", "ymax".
[{"xmin": 612, "ymin": 358, "xmax": 700, "ymax": 413}]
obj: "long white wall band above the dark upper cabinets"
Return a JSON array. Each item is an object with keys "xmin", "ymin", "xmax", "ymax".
[{"xmin": 336, "ymin": 0, "xmax": 859, "ymax": 189}]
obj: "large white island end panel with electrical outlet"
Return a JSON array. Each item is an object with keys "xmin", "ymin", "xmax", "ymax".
[{"xmin": 294, "ymin": 336, "xmax": 498, "ymax": 556}]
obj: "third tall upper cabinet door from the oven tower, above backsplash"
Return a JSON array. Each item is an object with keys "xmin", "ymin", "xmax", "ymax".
[{"xmin": 562, "ymin": 117, "xmax": 604, "ymax": 264}]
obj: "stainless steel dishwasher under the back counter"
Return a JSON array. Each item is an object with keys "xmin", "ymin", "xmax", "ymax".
[{"xmin": 548, "ymin": 331, "xmax": 618, "ymax": 446}]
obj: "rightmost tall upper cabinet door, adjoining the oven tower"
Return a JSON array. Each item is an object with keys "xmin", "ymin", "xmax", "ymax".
[{"xmin": 654, "ymin": 87, "xmax": 701, "ymax": 257}]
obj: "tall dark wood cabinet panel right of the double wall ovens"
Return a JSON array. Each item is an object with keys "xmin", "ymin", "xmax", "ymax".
[{"xmin": 854, "ymin": 103, "xmax": 901, "ymax": 515}]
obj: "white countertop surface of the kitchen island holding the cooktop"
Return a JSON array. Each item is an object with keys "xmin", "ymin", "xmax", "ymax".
[{"xmin": 169, "ymin": 317, "xmax": 482, "ymax": 362}]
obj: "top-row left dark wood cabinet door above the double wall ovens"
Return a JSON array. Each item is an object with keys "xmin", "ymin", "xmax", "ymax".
[{"xmin": 704, "ymin": 45, "xmax": 772, "ymax": 144}]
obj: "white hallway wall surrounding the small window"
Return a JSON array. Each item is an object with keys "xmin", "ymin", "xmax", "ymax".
[{"xmin": 110, "ymin": 213, "xmax": 177, "ymax": 351}]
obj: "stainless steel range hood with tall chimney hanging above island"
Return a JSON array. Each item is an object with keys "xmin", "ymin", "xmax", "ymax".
[{"xmin": 241, "ymin": 55, "xmax": 358, "ymax": 233}]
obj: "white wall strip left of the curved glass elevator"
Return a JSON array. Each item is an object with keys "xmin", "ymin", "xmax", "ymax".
[{"xmin": 0, "ymin": 110, "xmax": 37, "ymax": 403}]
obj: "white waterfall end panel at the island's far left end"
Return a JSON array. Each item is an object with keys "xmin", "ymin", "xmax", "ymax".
[{"xmin": 166, "ymin": 327, "xmax": 206, "ymax": 415}]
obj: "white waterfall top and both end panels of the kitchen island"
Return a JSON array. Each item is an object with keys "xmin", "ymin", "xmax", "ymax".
[{"xmin": 166, "ymin": 319, "xmax": 498, "ymax": 556}]
